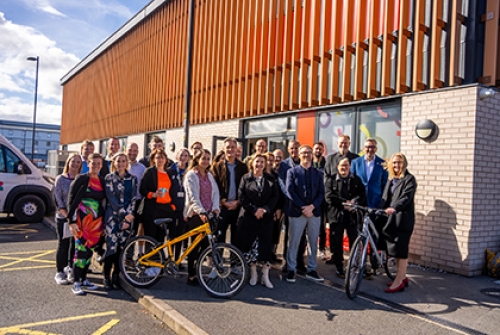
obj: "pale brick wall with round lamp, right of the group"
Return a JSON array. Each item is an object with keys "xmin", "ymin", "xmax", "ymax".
[{"xmin": 401, "ymin": 86, "xmax": 500, "ymax": 276}]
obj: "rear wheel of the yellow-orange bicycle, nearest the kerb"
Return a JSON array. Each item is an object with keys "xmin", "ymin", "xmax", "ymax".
[{"xmin": 120, "ymin": 236, "xmax": 163, "ymax": 288}]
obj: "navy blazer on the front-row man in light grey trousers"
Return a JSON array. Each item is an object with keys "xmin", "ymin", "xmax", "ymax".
[{"xmin": 285, "ymin": 165, "xmax": 325, "ymax": 217}]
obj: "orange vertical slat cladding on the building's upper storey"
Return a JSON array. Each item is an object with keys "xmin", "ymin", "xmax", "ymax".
[{"xmin": 61, "ymin": 0, "xmax": 486, "ymax": 143}]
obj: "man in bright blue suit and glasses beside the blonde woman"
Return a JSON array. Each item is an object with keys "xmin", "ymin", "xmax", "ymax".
[{"xmin": 351, "ymin": 138, "xmax": 387, "ymax": 208}]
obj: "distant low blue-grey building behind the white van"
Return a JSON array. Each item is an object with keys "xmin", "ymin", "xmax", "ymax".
[{"xmin": 0, "ymin": 120, "xmax": 61, "ymax": 164}]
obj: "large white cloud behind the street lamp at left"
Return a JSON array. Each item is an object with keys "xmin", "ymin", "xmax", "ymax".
[{"xmin": 0, "ymin": 12, "xmax": 79, "ymax": 123}]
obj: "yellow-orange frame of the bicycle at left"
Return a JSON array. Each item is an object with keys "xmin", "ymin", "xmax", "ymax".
[{"xmin": 138, "ymin": 222, "xmax": 212, "ymax": 268}]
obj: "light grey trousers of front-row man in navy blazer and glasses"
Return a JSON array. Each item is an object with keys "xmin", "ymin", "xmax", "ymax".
[{"xmin": 286, "ymin": 215, "xmax": 321, "ymax": 272}]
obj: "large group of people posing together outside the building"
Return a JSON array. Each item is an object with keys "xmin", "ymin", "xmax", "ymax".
[{"xmin": 55, "ymin": 135, "xmax": 416, "ymax": 294}]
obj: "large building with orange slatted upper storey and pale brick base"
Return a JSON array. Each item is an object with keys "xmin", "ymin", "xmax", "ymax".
[{"xmin": 61, "ymin": 0, "xmax": 500, "ymax": 275}]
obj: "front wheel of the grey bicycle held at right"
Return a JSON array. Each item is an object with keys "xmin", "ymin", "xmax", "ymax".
[{"xmin": 345, "ymin": 236, "xmax": 367, "ymax": 299}]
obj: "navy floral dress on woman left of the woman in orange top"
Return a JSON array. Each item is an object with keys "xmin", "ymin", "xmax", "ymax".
[{"xmin": 105, "ymin": 172, "xmax": 137, "ymax": 257}]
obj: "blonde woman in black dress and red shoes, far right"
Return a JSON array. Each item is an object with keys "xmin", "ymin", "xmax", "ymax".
[{"xmin": 381, "ymin": 153, "xmax": 417, "ymax": 293}]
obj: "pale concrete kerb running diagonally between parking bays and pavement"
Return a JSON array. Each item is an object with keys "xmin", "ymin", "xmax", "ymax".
[{"xmin": 42, "ymin": 216, "xmax": 208, "ymax": 335}]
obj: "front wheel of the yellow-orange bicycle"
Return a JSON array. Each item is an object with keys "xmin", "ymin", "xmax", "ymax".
[{"xmin": 196, "ymin": 243, "xmax": 248, "ymax": 298}]
